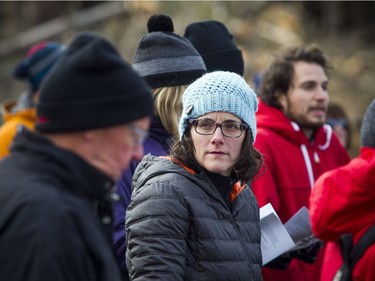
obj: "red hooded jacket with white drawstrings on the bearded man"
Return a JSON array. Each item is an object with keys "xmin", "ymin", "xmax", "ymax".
[{"xmin": 253, "ymin": 101, "xmax": 350, "ymax": 281}]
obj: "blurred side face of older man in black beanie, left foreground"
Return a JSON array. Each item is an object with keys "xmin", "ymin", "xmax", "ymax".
[{"xmin": 91, "ymin": 117, "xmax": 150, "ymax": 179}]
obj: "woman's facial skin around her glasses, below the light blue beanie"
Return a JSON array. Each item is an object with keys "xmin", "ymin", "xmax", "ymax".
[{"xmin": 190, "ymin": 112, "xmax": 246, "ymax": 176}]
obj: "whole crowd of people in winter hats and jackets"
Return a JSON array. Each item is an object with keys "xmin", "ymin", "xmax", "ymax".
[{"xmin": 0, "ymin": 15, "xmax": 375, "ymax": 281}]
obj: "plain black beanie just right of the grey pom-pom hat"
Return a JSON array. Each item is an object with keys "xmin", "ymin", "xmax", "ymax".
[{"xmin": 184, "ymin": 20, "xmax": 244, "ymax": 76}]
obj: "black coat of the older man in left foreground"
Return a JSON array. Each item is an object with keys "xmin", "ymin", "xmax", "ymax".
[{"xmin": 0, "ymin": 130, "xmax": 121, "ymax": 281}]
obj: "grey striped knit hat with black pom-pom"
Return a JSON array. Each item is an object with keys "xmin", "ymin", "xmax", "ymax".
[{"xmin": 133, "ymin": 15, "xmax": 206, "ymax": 88}]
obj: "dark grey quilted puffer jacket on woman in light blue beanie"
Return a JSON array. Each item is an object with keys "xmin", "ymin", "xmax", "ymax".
[{"xmin": 126, "ymin": 155, "xmax": 262, "ymax": 281}]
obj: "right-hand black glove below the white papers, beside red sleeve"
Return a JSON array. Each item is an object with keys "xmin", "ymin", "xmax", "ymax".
[{"xmin": 287, "ymin": 237, "xmax": 323, "ymax": 264}]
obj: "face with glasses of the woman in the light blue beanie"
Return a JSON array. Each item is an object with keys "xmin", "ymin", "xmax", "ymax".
[{"xmin": 190, "ymin": 112, "xmax": 245, "ymax": 176}]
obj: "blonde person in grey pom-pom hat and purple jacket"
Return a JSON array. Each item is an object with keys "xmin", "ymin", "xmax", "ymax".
[{"xmin": 114, "ymin": 15, "xmax": 206, "ymax": 275}]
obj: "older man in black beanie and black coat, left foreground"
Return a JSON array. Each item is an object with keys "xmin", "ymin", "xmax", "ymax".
[{"xmin": 0, "ymin": 32, "xmax": 153, "ymax": 281}]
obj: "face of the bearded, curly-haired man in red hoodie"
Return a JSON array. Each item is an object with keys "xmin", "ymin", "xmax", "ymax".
[{"xmin": 279, "ymin": 61, "xmax": 329, "ymax": 135}]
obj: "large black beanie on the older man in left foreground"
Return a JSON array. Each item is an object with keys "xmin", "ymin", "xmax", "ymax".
[{"xmin": 36, "ymin": 32, "xmax": 153, "ymax": 132}]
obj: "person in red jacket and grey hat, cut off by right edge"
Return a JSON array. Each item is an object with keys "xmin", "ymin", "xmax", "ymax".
[{"xmin": 310, "ymin": 99, "xmax": 375, "ymax": 281}]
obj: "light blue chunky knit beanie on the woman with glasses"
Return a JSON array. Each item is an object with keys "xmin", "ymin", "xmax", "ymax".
[{"xmin": 179, "ymin": 71, "xmax": 258, "ymax": 143}]
